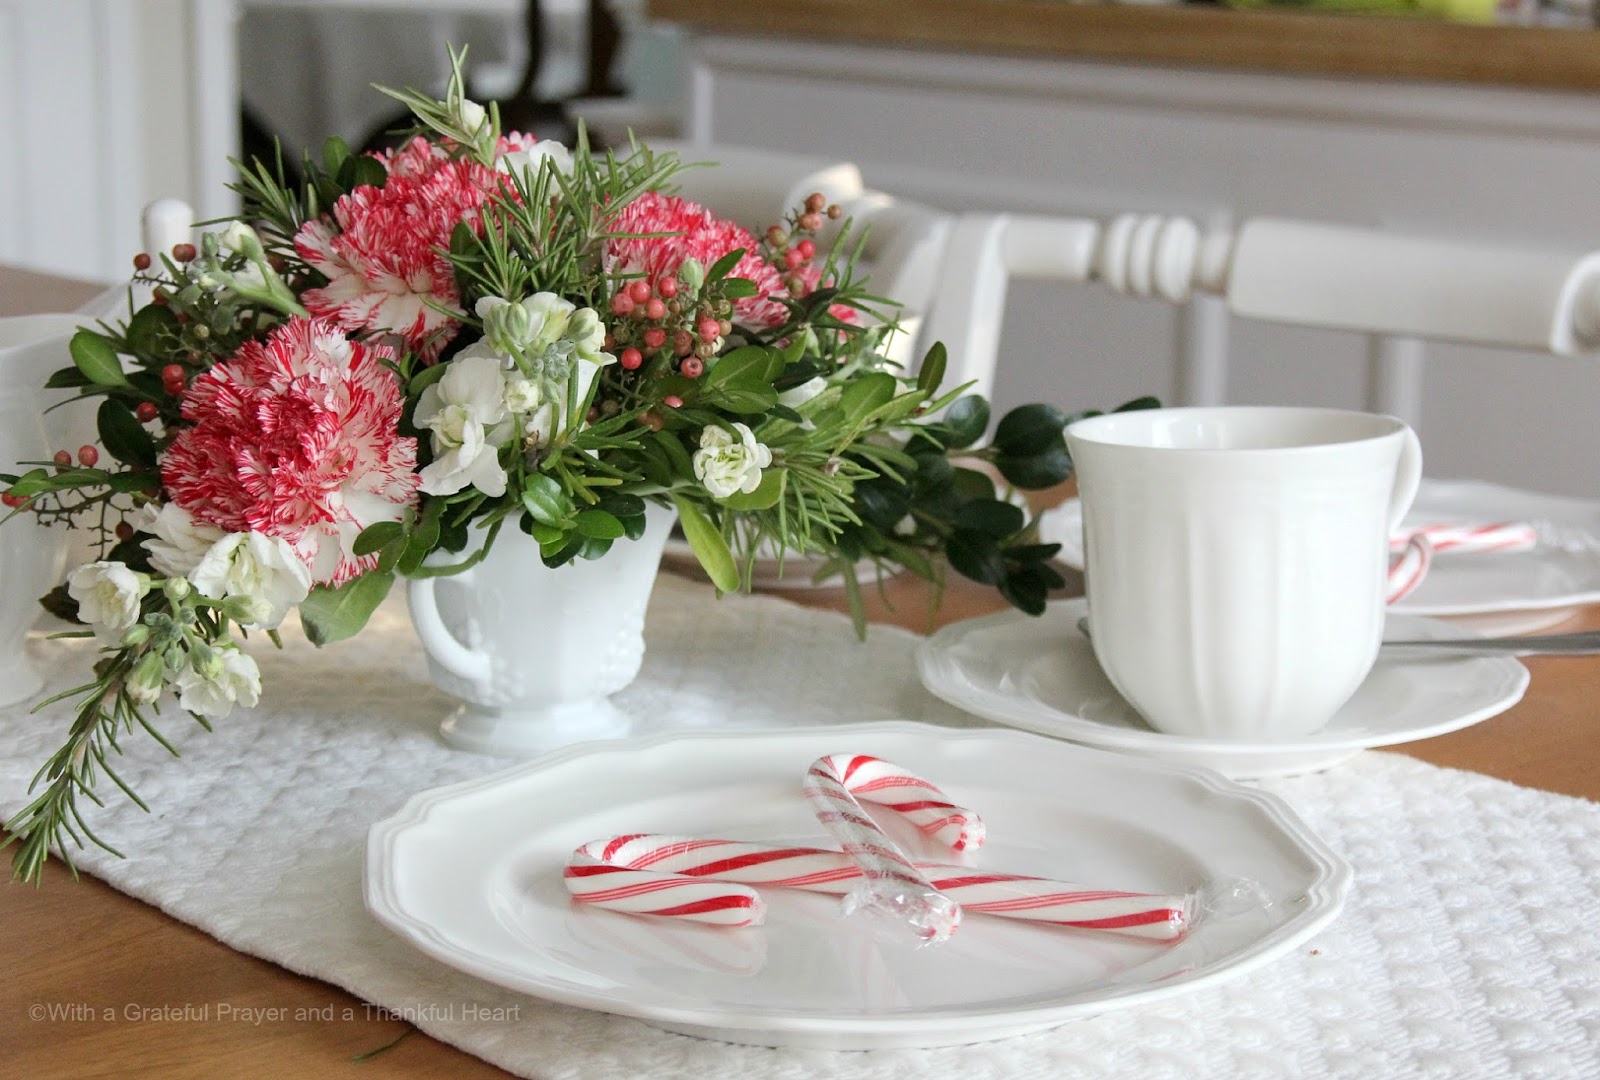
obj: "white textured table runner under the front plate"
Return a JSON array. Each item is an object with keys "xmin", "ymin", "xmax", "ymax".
[{"xmin": 0, "ymin": 576, "xmax": 1600, "ymax": 1080}]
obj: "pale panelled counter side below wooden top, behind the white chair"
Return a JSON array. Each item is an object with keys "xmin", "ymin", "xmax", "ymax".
[{"xmin": 686, "ymin": 34, "xmax": 1600, "ymax": 496}]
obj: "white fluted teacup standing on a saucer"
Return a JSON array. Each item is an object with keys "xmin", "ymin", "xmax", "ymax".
[{"xmin": 1067, "ymin": 406, "xmax": 1422, "ymax": 739}]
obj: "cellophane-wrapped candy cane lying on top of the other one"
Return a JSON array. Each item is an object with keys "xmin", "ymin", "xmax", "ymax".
[{"xmin": 800, "ymin": 754, "xmax": 962, "ymax": 944}]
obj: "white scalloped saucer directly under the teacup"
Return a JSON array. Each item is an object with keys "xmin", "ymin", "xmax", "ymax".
[{"xmin": 917, "ymin": 598, "xmax": 1528, "ymax": 779}]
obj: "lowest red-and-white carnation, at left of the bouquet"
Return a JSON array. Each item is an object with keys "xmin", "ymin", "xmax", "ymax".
[{"xmin": 162, "ymin": 318, "xmax": 418, "ymax": 586}]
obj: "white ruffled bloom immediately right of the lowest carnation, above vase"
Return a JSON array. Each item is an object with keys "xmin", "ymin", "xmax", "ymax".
[{"xmin": 416, "ymin": 352, "xmax": 510, "ymax": 498}]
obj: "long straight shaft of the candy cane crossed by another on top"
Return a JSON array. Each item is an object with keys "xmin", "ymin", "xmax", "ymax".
[{"xmin": 568, "ymin": 834, "xmax": 1195, "ymax": 941}]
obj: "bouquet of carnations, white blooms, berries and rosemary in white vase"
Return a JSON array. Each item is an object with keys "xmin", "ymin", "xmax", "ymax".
[{"xmin": 3, "ymin": 58, "xmax": 1152, "ymax": 878}]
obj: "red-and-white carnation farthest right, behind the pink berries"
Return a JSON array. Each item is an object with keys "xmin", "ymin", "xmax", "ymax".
[{"xmin": 603, "ymin": 192, "xmax": 789, "ymax": 330}]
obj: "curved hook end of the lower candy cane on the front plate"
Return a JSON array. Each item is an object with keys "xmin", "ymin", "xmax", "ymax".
[{"xmin": 562, "ymin": 837, "xmax": 766, "ymax": 926}]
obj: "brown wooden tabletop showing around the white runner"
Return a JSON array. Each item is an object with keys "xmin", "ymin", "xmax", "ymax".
[{"xmin": 0, "ymin": 267, "xmax": 1600, "ymax": 1080}]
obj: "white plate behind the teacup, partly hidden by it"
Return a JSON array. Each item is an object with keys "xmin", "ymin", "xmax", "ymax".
[{"xmin": 1040, "ymin": 480, "xmax": 1600, "ymax": 634}]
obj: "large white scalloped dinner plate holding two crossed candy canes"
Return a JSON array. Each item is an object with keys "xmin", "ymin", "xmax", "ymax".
[{"xmin": 366, "ymin": 723, "xmax": 1352, "ymax": 1050}]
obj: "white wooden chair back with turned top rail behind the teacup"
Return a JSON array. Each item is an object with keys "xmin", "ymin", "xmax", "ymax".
[{"xmin": 923, "ymin": 213, "xmax": 1600, "ymax": 424}]
